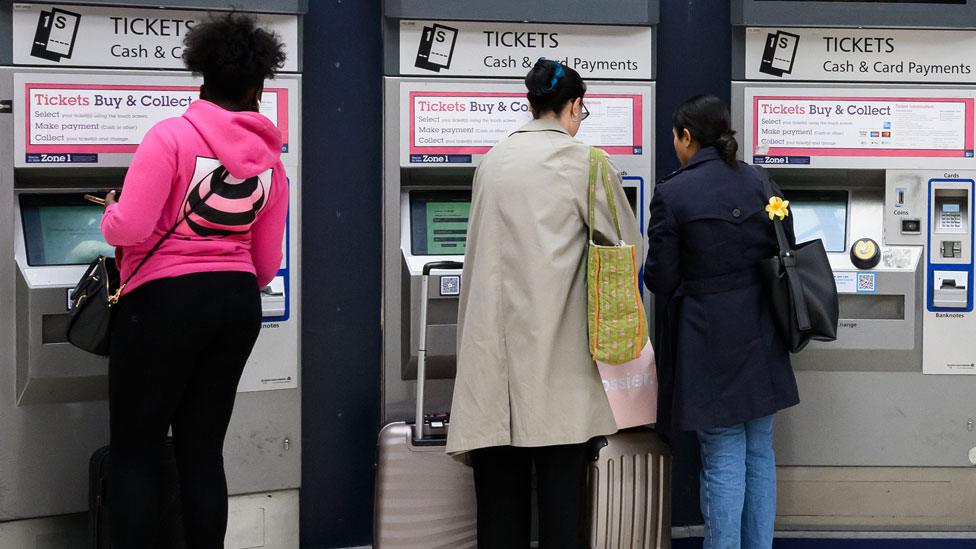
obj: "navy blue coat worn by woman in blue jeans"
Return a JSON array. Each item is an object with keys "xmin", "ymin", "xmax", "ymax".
[{"xmin": 644, "ymin": 147, "xmax": 799, "ymax": 431}]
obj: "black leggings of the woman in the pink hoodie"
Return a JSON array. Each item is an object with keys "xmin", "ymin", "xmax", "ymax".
[{"xmin": 109, "ymin": 272, "xmax": 261, "ymax": 549}]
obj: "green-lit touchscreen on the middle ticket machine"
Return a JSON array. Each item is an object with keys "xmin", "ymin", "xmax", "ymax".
[{"xmin": 410, "ymin": 191, "xmax": 471, "ymax": 255}]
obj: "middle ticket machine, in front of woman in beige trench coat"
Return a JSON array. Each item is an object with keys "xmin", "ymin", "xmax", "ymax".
[{"xmin": 383, "ymin": 0, "xmax": 658, "ymax": 422}]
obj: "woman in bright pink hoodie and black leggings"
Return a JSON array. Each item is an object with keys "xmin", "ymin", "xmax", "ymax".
[{"xmin": 102, "ymin": 14, "xmax": 288, "ymax": 549}]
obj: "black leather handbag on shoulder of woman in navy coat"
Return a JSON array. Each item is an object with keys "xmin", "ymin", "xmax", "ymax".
[{"xmin": 756, "ymin": 168, "xmax": 838, "ymax": 353}]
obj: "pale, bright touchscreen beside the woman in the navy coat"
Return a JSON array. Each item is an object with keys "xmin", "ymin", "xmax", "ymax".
[{"xmin": 784, "ymin": 191, "xmax": 848, "ymax": 252}]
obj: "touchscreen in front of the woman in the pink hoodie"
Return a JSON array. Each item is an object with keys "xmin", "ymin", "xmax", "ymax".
[{"xmin": 20, "ymin": 194, "xmax": 115, "ymax": 267}]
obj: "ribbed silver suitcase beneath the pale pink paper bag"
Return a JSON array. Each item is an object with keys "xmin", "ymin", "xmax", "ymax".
[{"xmin": 588, "ymin": 429, "xmax": 671, "ymax": 549}]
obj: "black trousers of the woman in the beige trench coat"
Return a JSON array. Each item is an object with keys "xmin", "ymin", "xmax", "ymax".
[{"xmin": 471, "ymin": 444, "xmax": 587, "ymax": 549}]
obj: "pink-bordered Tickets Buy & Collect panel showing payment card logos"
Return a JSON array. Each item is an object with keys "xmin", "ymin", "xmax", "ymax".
[{"xmin": 752, "ymin": 96, "xmax": 974, "ymax": 158}]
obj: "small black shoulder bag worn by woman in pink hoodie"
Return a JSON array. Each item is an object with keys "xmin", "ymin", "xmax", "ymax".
[{"xmin": 68, "ymin": 182, "xmax": 213, "ymax": 356}]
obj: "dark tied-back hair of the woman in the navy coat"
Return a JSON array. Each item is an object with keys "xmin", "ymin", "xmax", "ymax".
[{"xmin": 671, "ymin": 95, "xmax": 739, "ymax": 168}]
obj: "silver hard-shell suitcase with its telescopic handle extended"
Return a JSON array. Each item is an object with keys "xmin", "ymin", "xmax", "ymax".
[{"xmin": 373, "ymin": 261, "xmax": 478, "ymax": 549}]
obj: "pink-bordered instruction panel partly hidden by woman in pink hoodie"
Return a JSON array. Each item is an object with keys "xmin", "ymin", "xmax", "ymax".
[{"xmin": 14, "ymin": 73, "xmax": 291, "ymax": 166}]
